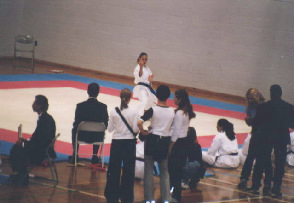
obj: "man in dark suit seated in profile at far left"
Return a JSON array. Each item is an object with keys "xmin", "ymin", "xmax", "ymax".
[{"xmin": 10, "ymin": 95, "xmax": 56, "ymax": 185}]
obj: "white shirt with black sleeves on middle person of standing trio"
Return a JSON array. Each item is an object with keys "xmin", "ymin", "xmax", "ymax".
[{"xmin": 141, "ymin": 105, "xmax": 175, "ymax": 137}]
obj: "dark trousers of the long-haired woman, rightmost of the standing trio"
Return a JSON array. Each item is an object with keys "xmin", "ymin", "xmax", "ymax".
[{"xmin": 168, "ymin": 138, "xmax": 187, "ymax": 202}]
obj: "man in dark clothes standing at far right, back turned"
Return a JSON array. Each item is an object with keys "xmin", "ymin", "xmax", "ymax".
[{"xmin": 252, "ymin": 85, "xmax": 294, "ymax": 197}]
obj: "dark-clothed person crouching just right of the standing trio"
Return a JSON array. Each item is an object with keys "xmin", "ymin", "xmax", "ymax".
[{"xmin": 182, "ymin": 127, "xmax": 205, "ymax": 189}]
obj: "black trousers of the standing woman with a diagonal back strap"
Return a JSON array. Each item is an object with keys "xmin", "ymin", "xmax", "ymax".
[{"xmin": 104, "ymin": 139, "xmax": 136, "ymax": 203}]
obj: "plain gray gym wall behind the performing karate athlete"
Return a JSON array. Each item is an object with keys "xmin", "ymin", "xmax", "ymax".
[{"xmin": 0, "ymin": 0, "xmax": 294, "ymax": 103}]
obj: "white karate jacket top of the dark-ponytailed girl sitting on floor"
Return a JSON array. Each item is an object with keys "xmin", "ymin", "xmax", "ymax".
[{"xmin": 208, "ymin": 132, "xmax": 238, "ymax": 155}]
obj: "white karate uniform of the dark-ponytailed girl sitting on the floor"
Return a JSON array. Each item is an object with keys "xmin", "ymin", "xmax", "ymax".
[{"xmin": 202, "ymin": 132, "xmax": 240, "ymax": 168}]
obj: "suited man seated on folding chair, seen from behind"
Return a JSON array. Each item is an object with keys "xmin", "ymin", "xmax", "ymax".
[{"xmin": 71, "ymin": 83, "xmax": 108, "ymax": 164}]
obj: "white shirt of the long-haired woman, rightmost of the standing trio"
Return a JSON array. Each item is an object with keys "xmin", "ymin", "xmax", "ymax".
[{"xmin": 171, "ymin": 110, "xmax": 190, "ymax": 142}]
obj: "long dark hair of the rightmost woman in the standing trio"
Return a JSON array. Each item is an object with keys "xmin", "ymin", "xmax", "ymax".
[{"xmin": 175, "ymin": 89, "xmax": 196, "ymax": 120}]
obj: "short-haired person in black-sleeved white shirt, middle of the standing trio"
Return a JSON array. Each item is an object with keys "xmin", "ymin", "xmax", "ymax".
[{"xmin": 138, "ymin": 85, "xmax": 175, "ymax": 202}]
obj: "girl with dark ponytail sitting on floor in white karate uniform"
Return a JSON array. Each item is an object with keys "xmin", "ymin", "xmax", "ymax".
[{"xmin": 202, "ymin": 119, "xmax": 240, "ymax": 168}]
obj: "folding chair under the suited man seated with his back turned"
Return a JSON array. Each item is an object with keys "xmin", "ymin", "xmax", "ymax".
[{"xmin": 74, "ymin": 121, "xmax": 106, "ymax": 168}]
